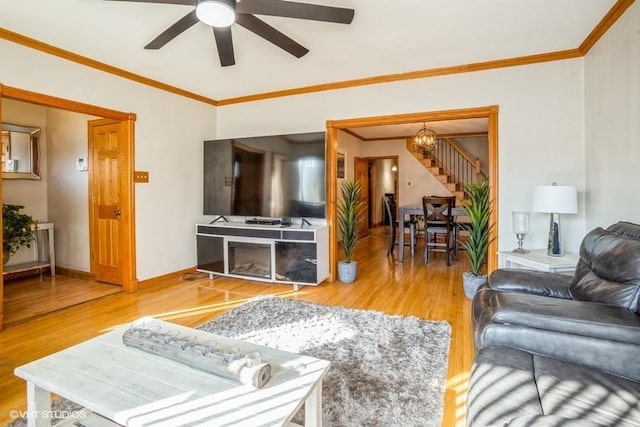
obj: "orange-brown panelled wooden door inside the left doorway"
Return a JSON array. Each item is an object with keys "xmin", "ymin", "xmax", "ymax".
[{"xmin": 89, "ymin": 120, "xmax": 123, "ymax": 285}]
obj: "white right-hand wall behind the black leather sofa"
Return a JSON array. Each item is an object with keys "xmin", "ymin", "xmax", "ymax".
[{"xmin": 585, "ymin": 2, "xmax": 640, "ymax": 230}]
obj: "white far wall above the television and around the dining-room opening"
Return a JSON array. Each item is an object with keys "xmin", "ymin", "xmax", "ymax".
[{"xmin": 216, "ymin": 58, "xmax": 585, "ymax": 251}]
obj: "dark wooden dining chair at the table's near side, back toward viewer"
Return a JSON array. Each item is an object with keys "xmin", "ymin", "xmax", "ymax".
[{"xmin": 422, "ymin": 196, "xmax": 457, "ymax": 266}]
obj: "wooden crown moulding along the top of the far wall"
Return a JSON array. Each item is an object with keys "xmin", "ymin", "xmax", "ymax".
[{"xmin": 217, "ymin": 49, "xmax": 582, "ymax": 106}]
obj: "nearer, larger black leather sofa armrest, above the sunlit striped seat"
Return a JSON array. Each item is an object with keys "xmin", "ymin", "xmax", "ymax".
[{"xmin": 473, "ymin": 288, "xmax": 640, "ymax": 380}]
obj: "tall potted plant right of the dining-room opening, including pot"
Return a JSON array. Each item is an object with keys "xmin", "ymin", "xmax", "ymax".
[{"xmin": 460, "ymin": 178, "xmax": 493, "ymax": 298}]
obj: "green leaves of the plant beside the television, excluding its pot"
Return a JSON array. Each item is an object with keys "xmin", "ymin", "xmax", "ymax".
[{"xmin": 337, "ymin": 180, "xmax": 363, "ymax": 262}]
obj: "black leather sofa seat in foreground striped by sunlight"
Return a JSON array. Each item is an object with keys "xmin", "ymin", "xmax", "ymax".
[{"xmin": 467, "ymin": 347, "xmax": 640, "ymax": 426}]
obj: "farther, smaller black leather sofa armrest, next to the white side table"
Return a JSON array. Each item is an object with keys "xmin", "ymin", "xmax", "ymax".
[{"xmin": 489, "ymin": 268, "xmax": 573, "ymax": 299}]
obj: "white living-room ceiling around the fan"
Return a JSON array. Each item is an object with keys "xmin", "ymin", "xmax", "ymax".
[{"xmin": 0, "ymin": 0, "xmax": 615, "ymax": 100}]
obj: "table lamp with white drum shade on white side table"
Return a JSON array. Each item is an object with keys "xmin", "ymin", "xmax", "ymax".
[{"xmin": 533, "ymin": 182, "xmax": 578, "ymax": 256}]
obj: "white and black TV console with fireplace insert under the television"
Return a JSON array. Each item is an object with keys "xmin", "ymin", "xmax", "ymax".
[{"xmin": 196, "ymin": 222, "xmax": 329, "ymax": 291}]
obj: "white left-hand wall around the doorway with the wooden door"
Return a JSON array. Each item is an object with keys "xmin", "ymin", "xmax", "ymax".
[{"xmin": 0, "ymin": 40, "xmax": 216, "ymax": 280}]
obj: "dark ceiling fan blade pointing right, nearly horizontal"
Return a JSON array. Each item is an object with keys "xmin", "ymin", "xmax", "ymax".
[{"xmin": 236, "ymin": 0, "xmax": 354, "ymax": 24}]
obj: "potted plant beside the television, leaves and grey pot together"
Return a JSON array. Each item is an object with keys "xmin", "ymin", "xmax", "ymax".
[{"xmin": 337, "ymin": 180, "xmax": 362, "ymax": 283}]
